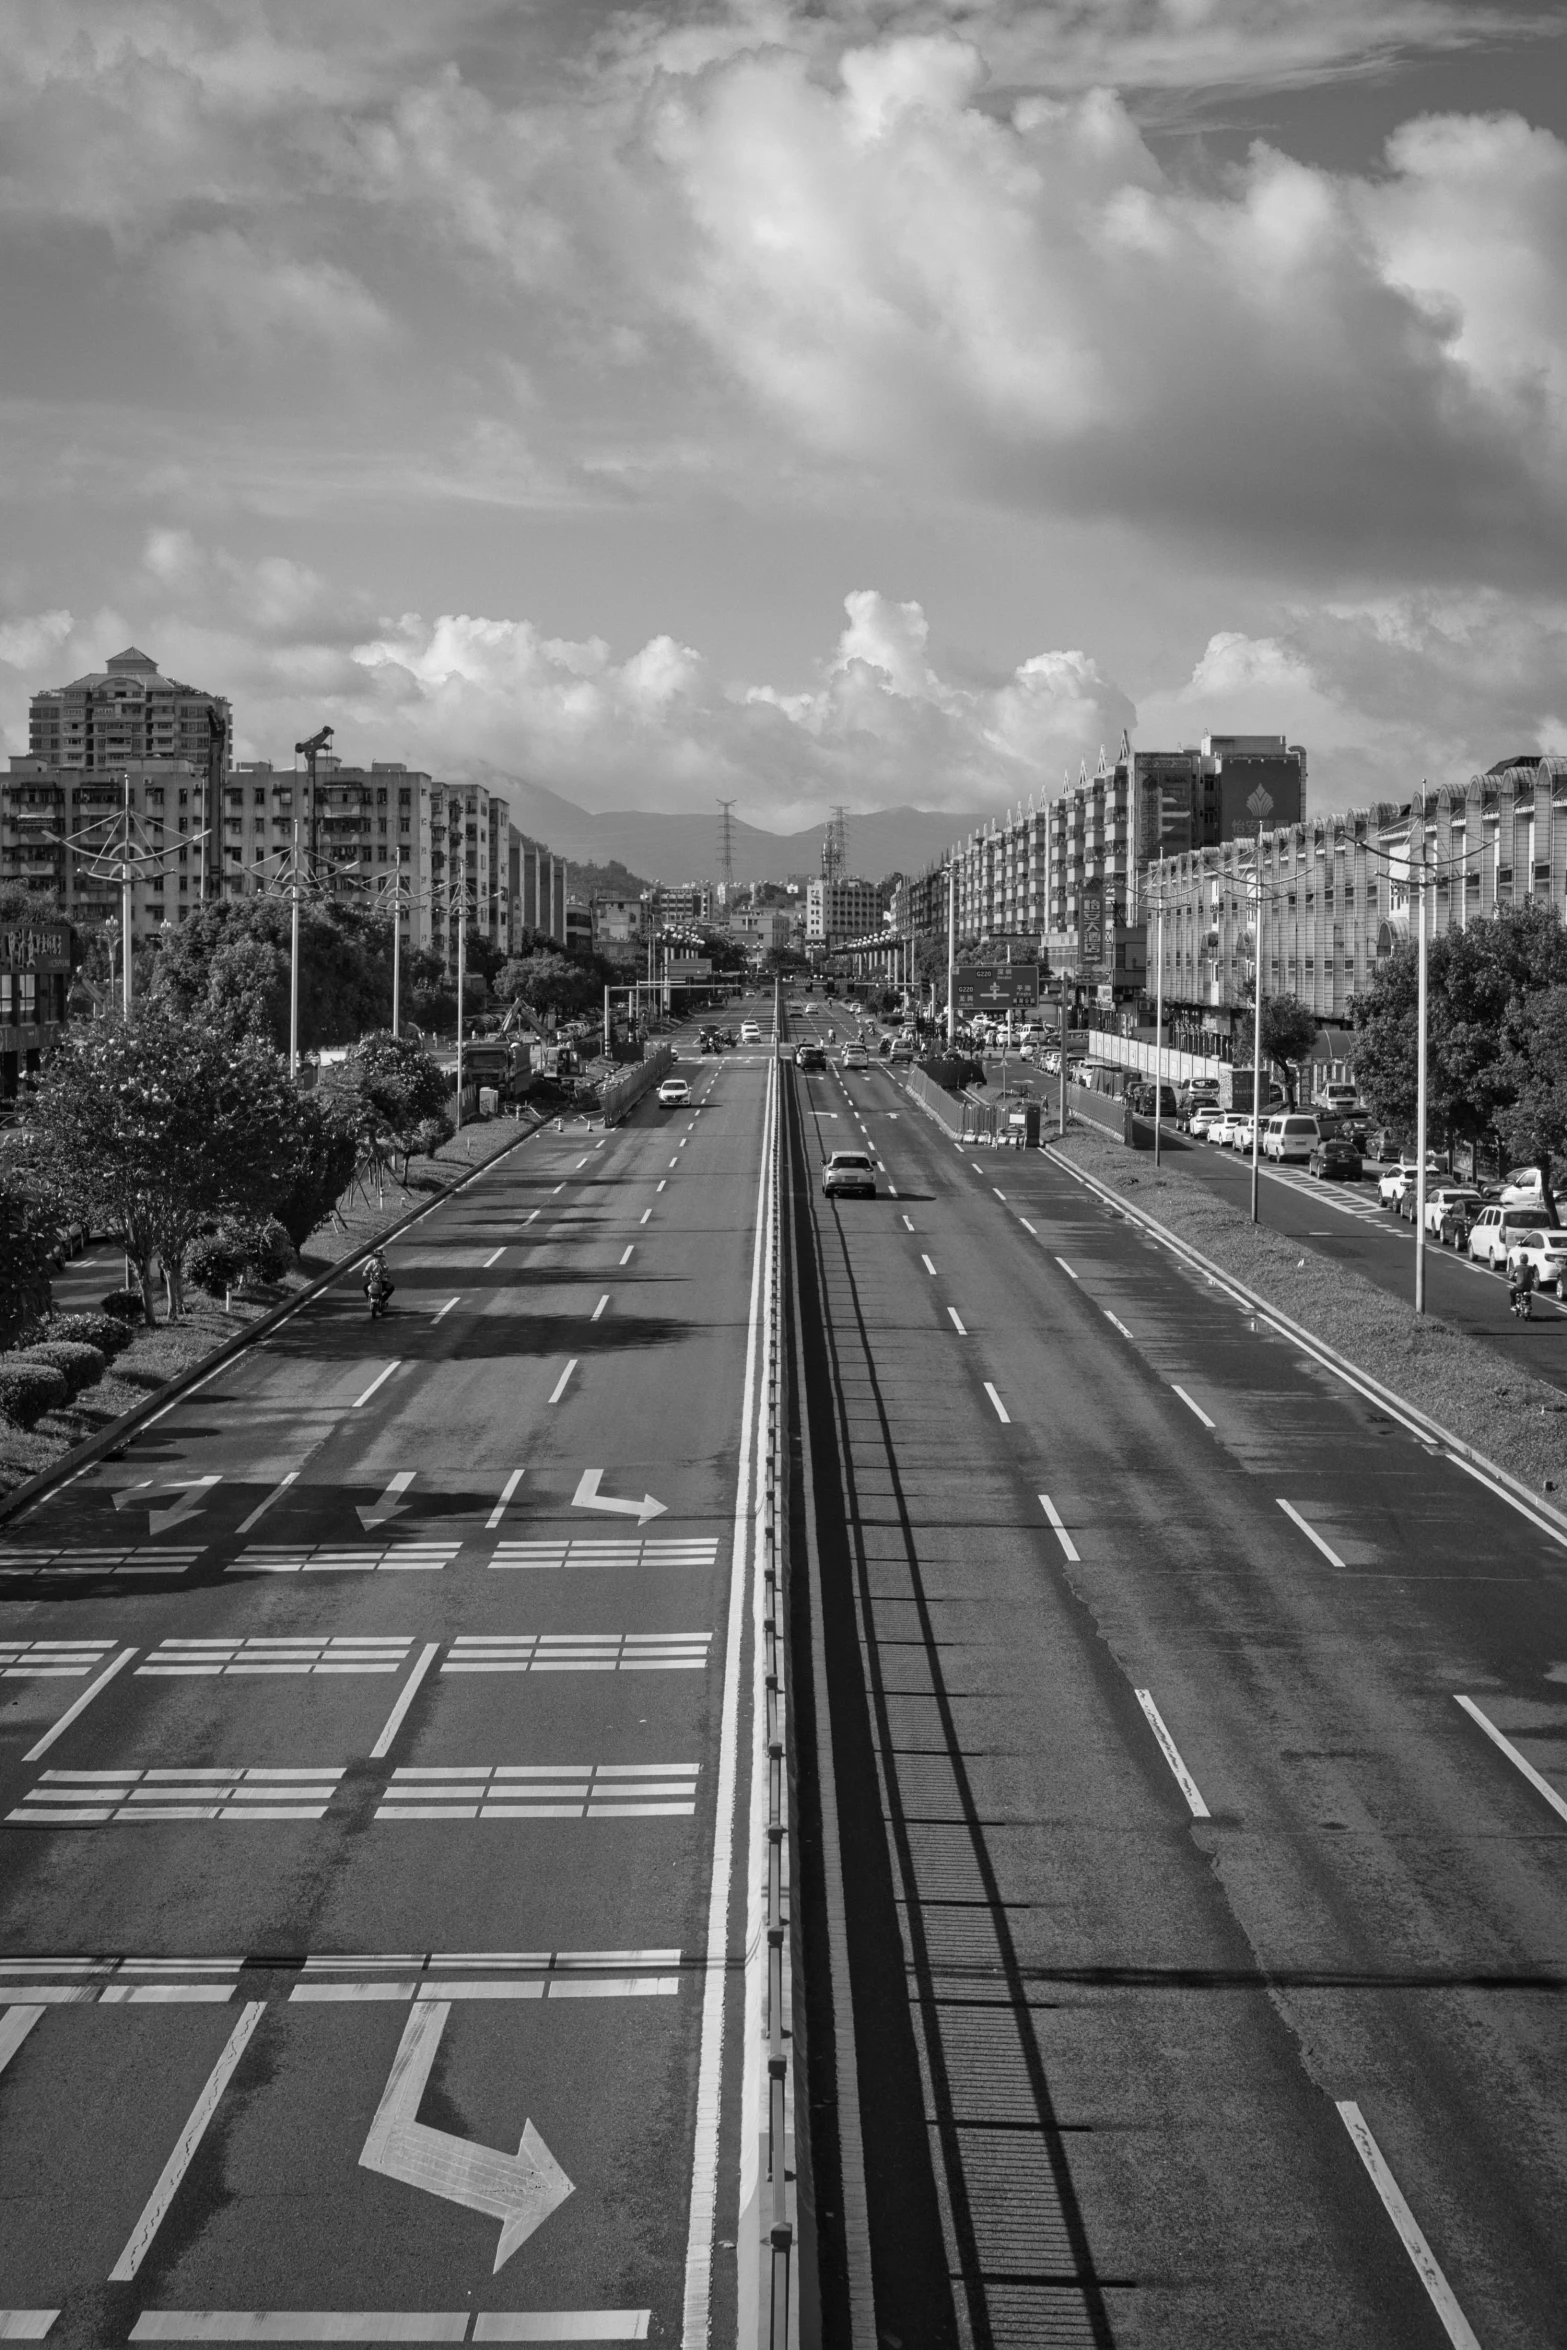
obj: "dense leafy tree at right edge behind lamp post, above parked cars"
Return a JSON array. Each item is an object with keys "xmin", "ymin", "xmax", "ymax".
[{"xmin": 1353, "ymin": 900, "xmax": 1567, "ymax": 1144}]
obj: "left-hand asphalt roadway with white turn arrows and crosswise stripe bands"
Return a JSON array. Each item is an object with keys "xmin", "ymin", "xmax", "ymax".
[{"xmin": 0, "ymin": 1024, "xmax": 771, "ymax": 2345}]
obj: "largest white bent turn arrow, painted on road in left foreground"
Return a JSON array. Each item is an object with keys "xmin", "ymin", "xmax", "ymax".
[{"xmin": 359, "ymin": 2000, "xmax": 576, "ymax": 2270}]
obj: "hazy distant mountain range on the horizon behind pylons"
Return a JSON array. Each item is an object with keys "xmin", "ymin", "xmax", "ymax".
[{"xmin": 486, "ymin": 773, "xmax": 980, "ymax": 881}]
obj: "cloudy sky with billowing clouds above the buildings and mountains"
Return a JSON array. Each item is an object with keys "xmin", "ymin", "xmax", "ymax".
[{"xmin": 0, "ymin": 0, "xmax": 1567, "ymax": 827}]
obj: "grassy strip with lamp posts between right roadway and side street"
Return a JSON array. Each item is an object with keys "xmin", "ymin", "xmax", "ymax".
[{"xmin": 1055, "ymin": 1126, "xmax": 1567, "ymax": 1497}]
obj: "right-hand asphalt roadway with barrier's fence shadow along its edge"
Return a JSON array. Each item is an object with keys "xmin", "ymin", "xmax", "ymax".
[{"xmin": 787, "ymin": 1022, "xmax": 1567, "ymax": 2350}]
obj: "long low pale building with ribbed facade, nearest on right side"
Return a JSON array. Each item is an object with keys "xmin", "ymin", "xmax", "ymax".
[{"xmin": 1144, "ymin": 757, "xmax": 1567, "ymax": 1036}]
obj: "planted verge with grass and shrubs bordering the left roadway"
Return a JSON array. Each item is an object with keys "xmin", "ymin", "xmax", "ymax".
[{"xmin": 0, "ymin": 1112, "xmax": 552, "ymax": 1502}]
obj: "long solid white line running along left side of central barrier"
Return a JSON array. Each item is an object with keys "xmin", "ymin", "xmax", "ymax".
[{"xmin": 681, "ymin": 1062, "xmax": 778, "ymax": 2350}]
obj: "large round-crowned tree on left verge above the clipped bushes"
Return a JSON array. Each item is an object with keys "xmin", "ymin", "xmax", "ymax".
[{"xmin": 33, "ymin": 1003, "xmax": 310, "ymax": 1323}]
